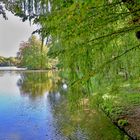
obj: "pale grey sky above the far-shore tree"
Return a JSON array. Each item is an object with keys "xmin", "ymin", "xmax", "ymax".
[{"xmin": 0, "ymin": 11, "xmax": 37, "ymax": 57}]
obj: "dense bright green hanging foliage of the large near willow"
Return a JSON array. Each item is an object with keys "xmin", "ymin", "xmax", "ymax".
[{"xmin": 41, "ymin": 1, "xmax": 140, "ymax": 93}]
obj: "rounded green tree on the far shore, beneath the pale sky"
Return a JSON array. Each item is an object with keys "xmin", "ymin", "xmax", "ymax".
[{"xmin": 18, "ymin": 36, "xmax": 48, "ymax": 69}]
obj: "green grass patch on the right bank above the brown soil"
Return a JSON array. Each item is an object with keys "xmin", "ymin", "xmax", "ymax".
[{"xmin": 92, "ymin": 83, "xmax": 140, "ymax": 120}]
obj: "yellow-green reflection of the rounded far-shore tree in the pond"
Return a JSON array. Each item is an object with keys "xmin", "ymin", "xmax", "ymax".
[{"xmin": 17, "ymin": 71, "xmax": 60, "ymax": 98}]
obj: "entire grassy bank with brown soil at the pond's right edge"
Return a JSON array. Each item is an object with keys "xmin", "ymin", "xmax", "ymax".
[{"xmin": 92, "ymin": 81, "xmax": 140, "ymax": 140}]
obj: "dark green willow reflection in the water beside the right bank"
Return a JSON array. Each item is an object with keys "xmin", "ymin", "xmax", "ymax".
[{"xmin": 47, "ymin": 85, "xmax": 124, "ymax": 140}]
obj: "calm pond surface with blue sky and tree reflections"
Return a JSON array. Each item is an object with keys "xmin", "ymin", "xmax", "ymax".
[{"xmin": 0, "ymin": 71, "xmax": 124, "ymax": 140}]
